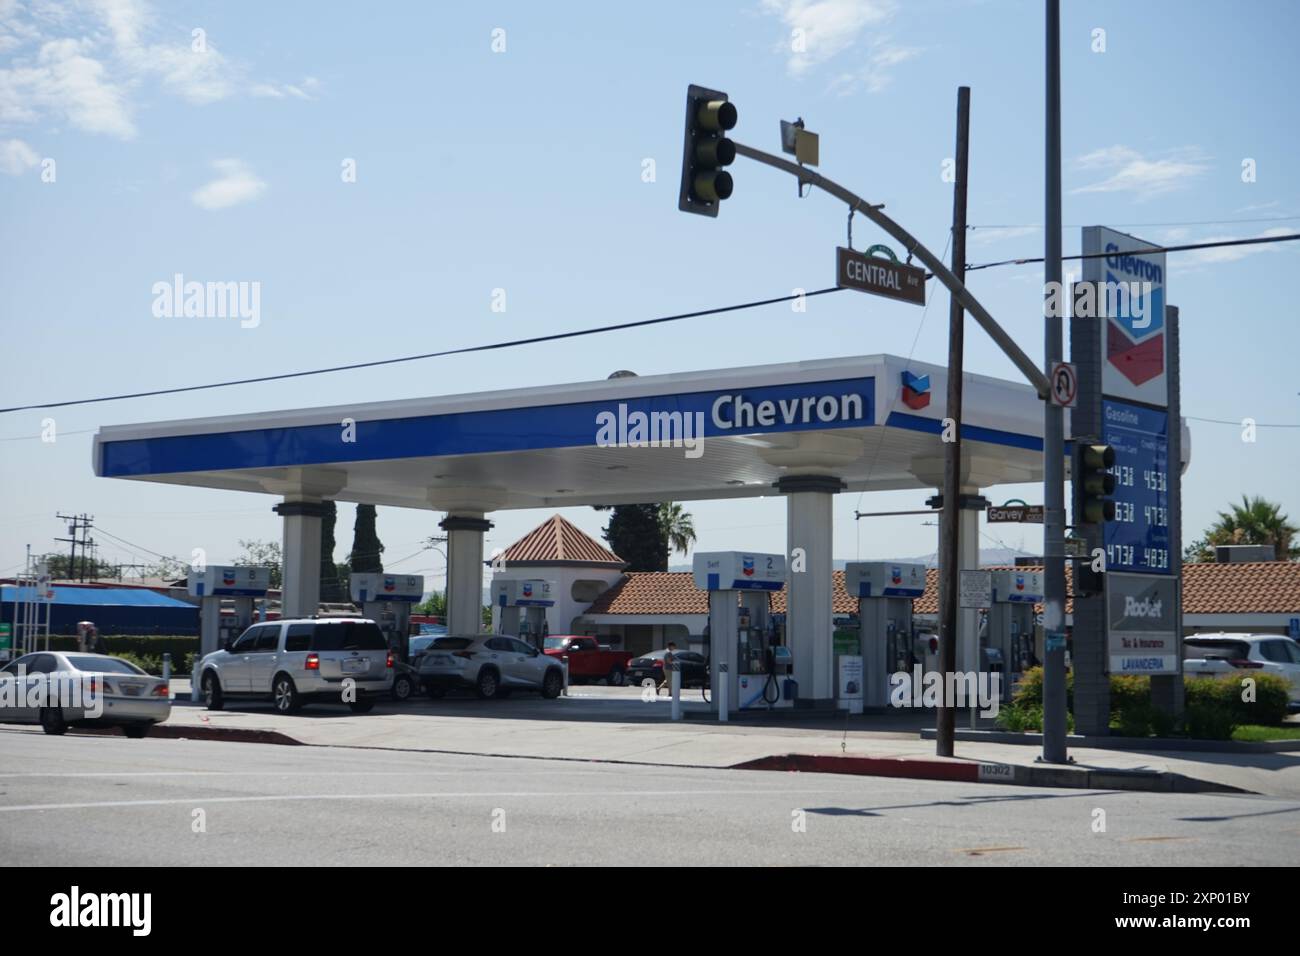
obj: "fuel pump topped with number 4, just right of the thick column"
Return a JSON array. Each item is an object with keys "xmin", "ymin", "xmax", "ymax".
[{"xmin": 844, "ymin": 561, "xmax": 926, "ymax": 708}]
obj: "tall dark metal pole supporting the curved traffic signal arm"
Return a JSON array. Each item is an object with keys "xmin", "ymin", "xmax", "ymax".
[{"xmin": 1043, "ymin": 0, "xmax": 1067, "ymax": 763}]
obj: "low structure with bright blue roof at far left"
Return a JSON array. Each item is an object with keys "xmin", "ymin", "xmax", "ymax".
[{"xmin": 0, "ymin": 584, "xmax": 199, "ymax": 636}]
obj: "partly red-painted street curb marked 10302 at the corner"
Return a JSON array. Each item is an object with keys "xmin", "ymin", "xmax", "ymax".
[{"xmin": 731, "ymin": 753, "xmax": 1253, "ymax": 793}]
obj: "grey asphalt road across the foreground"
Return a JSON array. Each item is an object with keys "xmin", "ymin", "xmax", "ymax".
[{"xmin": 0, "ymin": 726, "xmax": 1300, "ymax": 866}]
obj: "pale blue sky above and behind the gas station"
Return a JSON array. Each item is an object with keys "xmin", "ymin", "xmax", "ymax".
[{"xmin": 0, "ymin": 0, "xmax": 1300, "ymax": 587}]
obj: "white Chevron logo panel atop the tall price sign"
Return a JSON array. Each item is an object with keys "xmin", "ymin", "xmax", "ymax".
[{"xmin": 1083, "ymin": 226, "xmax": 1169, "ymax": 407}]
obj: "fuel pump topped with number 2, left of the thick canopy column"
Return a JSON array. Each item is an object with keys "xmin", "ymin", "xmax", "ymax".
[{"xmin": 693, "ymin": 551, "xmax": 798, "ymax": 715}]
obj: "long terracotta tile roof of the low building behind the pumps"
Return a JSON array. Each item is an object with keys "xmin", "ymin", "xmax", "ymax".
[{"xmin": 586, "ymin": 561, "xmax": 1300, "ymax": 615}]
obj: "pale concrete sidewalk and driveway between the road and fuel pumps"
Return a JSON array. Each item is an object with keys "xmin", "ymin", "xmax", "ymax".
[{"xmin": 154, "ymin": 680, "xmax": 1300, "ymax": 799}]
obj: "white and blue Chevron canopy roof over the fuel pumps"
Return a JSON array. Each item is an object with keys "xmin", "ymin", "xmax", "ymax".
[{"xmin": 94, "ymin": 355, "xmax": 1128, "ymax": 511}]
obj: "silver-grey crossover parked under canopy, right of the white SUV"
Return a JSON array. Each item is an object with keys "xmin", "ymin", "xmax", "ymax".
[{"xmin": 419, "ymin": 633, "xmax": 564, "ymax": 698}]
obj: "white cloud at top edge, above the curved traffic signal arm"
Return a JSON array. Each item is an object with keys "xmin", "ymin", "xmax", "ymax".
[{"xmin": 762, "ymin": 0, "xmax": 919, "ymax": 92}]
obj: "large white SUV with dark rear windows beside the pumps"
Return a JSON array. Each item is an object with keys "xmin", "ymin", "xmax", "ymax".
[{"xmin": 199, "ymin": 618, "xmax": 393, "ymax": 714}]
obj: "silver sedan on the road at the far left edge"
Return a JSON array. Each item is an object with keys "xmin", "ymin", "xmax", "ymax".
[{"xmin": 0, "ymin": 650, "xmax": 172, "ymax": 737}]
